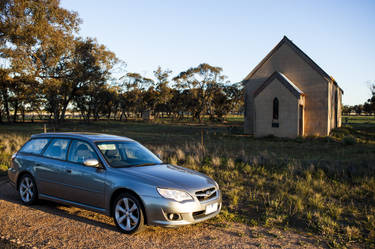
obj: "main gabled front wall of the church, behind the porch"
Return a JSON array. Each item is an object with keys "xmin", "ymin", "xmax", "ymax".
[{"xmin": 245, "ymin": 43, "xmax": 329, "ymax": 136}]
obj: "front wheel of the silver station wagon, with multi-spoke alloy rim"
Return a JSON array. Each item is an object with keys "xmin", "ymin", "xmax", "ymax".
[{"xmin": 112, "ymin": 193, "xmax": 144, "ymax": 234}]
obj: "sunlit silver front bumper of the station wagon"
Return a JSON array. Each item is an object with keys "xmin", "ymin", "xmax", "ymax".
[{"xmin": 142, "ymin": 191, "xmax": 222, "ymax": 227}]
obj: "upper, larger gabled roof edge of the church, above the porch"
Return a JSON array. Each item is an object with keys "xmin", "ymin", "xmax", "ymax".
[{"xmin": 243, "ymin": 36, "xmax": 344, "ymax": 93}]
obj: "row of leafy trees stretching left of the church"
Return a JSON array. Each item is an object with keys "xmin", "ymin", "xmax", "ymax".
[{"xmin": 0, "ymin": 0, "xmax": 243, "ymax": 122}]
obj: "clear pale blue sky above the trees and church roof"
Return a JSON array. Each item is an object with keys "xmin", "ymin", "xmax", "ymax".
[{"xmin": 61, "ymin": 0, "xmax": 375, "ymax": 105}]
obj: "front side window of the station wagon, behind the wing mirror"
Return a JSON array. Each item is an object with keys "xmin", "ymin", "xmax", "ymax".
[{"xmin": 68, "ymin": 140, "xmax": 99, "ymax": 163}]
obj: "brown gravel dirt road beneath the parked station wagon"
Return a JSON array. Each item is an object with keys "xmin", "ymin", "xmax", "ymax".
[{"xmin": 0, "ymin": 177, "xmax": 322, "ymax": 249}]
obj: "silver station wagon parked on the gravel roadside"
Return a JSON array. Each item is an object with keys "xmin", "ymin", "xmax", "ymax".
[{"xmin": 8, "ymin": 133, "xmax": 221, "ymax": 234}]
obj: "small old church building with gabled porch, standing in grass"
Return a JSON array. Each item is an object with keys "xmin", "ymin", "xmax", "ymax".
[{"xmin": 243, "ymin": 36, "xmax": 343, "ymax": 138}]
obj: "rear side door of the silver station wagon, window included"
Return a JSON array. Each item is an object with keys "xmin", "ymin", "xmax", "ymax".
[{"xmin": 35, "ymin": 138, "xmax": 70, "ymax": 198}]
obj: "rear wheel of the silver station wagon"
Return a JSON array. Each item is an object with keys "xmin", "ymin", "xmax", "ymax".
[{"xmin": 18, "ymin": 174, "xmax": 38, "ymax": 205}]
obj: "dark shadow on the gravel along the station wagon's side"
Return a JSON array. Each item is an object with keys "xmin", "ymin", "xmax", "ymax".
[{"xmin": 0, "ymin": 179, "xmax": 122, "ymax": 234}]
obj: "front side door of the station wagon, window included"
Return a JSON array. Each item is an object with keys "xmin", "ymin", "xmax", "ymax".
[{"xmin": 64, "ymin": 140, "xmax": 106, "ymax": 208}]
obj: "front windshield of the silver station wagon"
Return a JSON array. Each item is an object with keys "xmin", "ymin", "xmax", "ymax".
[{"xmin": 96, "ymin": 141, "xmax": 162, "ymax": 168}]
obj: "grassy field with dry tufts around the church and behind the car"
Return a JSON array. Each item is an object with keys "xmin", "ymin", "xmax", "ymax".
[{"xmin": 0, "ymin": 117, "xmax": 375, "ymax": 247}]
